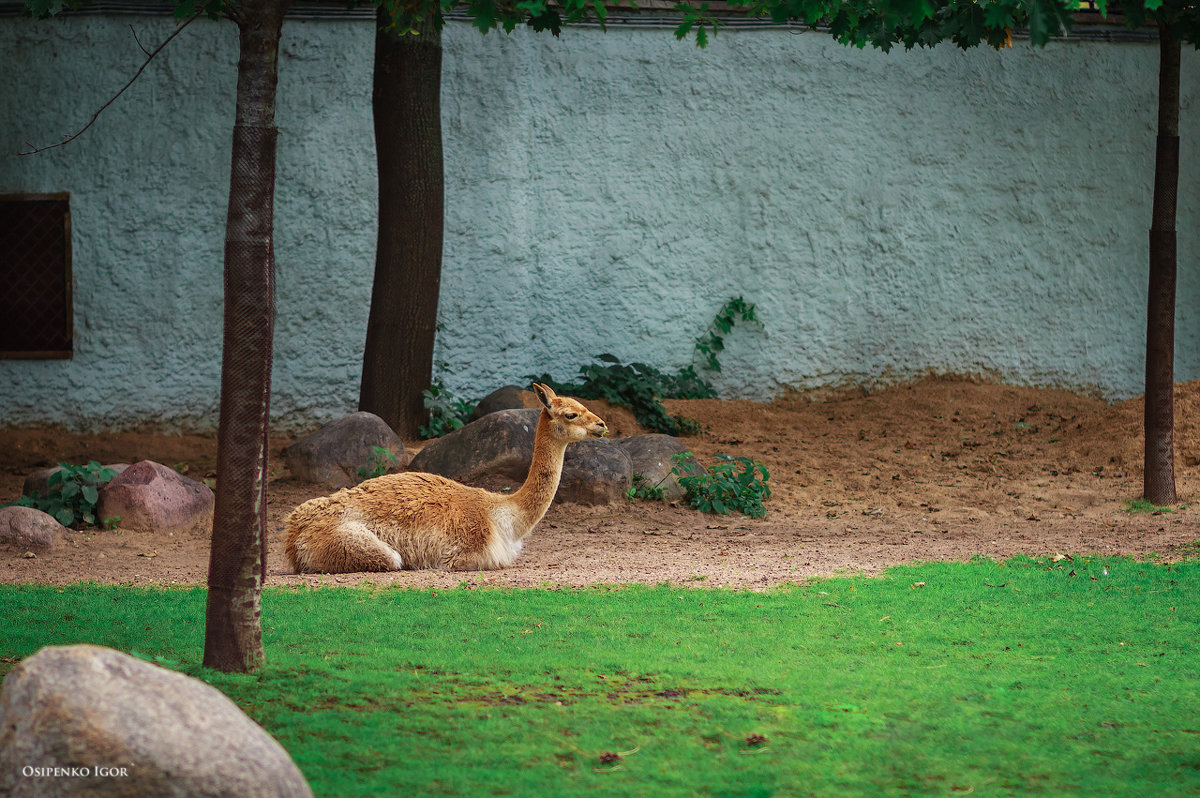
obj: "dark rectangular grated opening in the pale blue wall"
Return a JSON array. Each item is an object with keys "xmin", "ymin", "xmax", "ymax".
[{"xmin": 0, "ymin": 194, "xmax": 73, "ymax": 358}]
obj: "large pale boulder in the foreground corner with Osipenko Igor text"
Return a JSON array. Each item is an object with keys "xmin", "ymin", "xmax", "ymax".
[{"xmin": 0, "ymin": 646, "xmax": 312, "ymax": 798}]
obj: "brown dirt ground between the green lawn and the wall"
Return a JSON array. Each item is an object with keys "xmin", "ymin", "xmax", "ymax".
[{"xmin": 0, "ymin": 377, "xmax": 1200, "ymax": 588}]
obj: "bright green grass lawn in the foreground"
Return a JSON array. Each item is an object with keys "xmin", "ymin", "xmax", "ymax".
[{"xmin": 0, "ymin": 559, "xmax": 1200, "ymax": 796}]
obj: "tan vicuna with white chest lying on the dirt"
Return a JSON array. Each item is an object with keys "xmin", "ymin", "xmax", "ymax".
[{"xmin": 284, "ymin": 384, "xmax": 608, "ymax": 574}]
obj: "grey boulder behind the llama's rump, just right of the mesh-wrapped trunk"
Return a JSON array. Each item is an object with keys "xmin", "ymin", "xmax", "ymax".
[{"xmin": 283, "ymin": 412, "xmax": 408, "ymax": 488}]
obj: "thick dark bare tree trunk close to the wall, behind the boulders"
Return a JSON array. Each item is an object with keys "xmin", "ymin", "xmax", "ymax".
[{"xmin": 359, "ymin": 8, "xmax": 444, "ymax": 439}]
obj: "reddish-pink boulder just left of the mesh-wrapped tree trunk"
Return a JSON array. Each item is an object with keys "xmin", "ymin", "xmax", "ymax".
[{"xmin": 96, "ymin": 460, "xmax": 215, "ymax": 533}]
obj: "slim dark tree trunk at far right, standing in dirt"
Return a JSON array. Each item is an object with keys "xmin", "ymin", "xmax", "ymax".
[{"xmin": 1142, "ymin": 23, "xmax": 1180, "ymax": 504}]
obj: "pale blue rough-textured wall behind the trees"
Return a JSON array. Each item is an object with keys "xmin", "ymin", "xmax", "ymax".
[{"xmin": 0, "ymin": 17, "xmax": 1200, "ymax": 427}]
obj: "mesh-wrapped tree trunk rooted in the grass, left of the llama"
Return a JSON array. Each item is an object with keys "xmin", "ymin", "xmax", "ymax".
[{"xmin": 204, "ymin": 0, "xmax": 289, "ymax": 672}]
